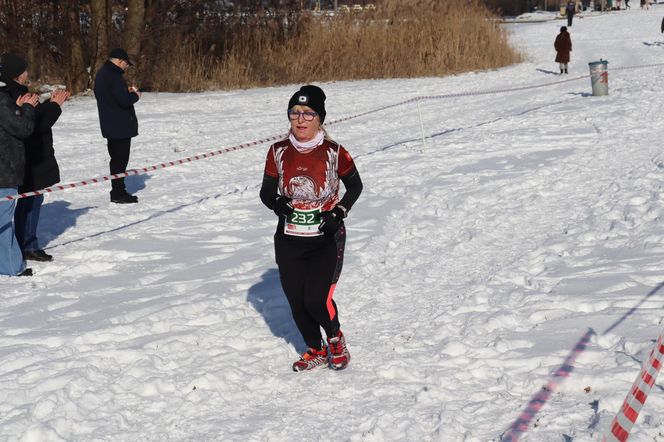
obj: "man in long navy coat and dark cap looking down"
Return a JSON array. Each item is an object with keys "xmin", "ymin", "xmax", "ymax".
[{"xmin": 94, "ymin": 48, "xmax": 141, "ymax": 204}]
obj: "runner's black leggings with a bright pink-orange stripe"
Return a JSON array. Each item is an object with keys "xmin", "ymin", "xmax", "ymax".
[{"xmin": 274, "ymin": 226, "xmax": 346, "ymax": 349}]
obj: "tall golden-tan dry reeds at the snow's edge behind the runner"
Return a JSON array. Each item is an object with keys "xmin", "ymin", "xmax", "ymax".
[{"xmin": 148, "ymin": 0, "xmax": 521, "ymax": 91}]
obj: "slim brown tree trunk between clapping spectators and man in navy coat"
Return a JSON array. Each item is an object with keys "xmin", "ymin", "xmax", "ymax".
[{"xmin": 65, "ymin": 0, "xmax": 90, "ymax": 94}]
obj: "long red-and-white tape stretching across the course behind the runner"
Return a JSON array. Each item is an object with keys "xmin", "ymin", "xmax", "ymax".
[{"xmin": 6, "ymin": 63, "xmax": 664, "ymax": 201}]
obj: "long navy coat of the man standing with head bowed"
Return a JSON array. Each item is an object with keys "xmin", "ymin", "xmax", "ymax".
[{"xmin": 95, "ymin": 61, "xmax": 138, "ymax": 140}]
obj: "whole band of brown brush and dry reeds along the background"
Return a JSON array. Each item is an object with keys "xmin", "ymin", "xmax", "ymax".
[{"xmin": 0, "ymin": 0, "xmax": 519, "ymax": 92}]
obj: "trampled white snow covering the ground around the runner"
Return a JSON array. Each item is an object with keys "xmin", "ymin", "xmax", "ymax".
[{"xmin": 0, "ymin": 3, "xmax": 664, "ymax": 442}]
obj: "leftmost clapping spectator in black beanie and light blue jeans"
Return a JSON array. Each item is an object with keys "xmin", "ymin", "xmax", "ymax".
[{"xmin": 0, "ymin": 54, "xmax": 39, "ymax": 276}]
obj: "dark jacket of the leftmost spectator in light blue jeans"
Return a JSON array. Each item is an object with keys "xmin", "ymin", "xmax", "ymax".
[{"xmin": 0, "ymin": 83, "xmax": 35, "ymax": 188}]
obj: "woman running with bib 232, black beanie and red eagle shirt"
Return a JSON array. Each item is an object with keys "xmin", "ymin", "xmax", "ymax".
[{"xmin": 260, "ymin": 85, "xmax": 362, "ymax": 371}]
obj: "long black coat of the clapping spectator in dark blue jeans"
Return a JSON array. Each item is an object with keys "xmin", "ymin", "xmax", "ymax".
[{"xmin": 7, "ymin": 81, "xmax": 62, "ymax": 192}]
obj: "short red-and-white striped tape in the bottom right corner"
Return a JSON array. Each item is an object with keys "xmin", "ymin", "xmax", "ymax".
[{"xmin": 602, "ymin": 335, "xmax": 664, "ymax": 442}]
